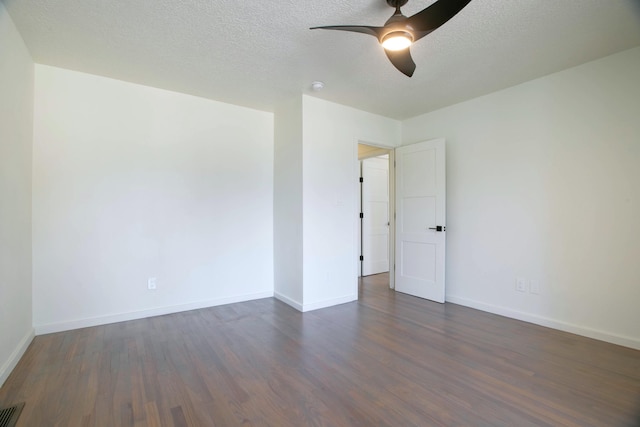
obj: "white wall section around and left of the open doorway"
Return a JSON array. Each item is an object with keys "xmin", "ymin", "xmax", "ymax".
[{"xmin": 302, "ymin": 95, "xmax": 400, "ymax": 311}]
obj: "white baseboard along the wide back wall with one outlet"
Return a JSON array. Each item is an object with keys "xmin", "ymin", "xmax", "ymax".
[{"xmin": 34, "ymin": 291, "xmax": 273, "ymax": 335}]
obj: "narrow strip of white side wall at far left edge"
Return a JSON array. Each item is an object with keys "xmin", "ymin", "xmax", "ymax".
[{"xmin": 0, "ymin": 3, "xmax": 33, "ymax": 386}]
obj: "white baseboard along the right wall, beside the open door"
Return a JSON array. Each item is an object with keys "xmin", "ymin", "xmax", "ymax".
[{"xmin": 447, "ymin": 295, "xmax": 640, "ymax": 350}]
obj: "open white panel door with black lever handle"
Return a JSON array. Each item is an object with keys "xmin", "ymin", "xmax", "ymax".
[{"xmin": 395, "ymin": 139, "xmax": 446, "ymax": 302}]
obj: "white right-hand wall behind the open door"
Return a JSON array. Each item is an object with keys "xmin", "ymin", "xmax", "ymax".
[{"xmin": 403, "ymin": 48, "xmax": 640, "ymax": 348}]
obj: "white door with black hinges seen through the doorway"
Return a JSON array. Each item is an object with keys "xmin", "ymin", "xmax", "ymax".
[{"xmin": 362, "ymin": 155, "xmax": 389, "ymax": 276}]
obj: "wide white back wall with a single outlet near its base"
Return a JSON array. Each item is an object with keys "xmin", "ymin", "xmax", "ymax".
[{"xmin": 33, "ymin": 65, "xmax": 273, "ymax": 333}]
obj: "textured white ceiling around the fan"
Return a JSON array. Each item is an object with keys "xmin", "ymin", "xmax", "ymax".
[{"xmin": 3, "ymin": 0, "xmax": 640, "ymax": 119}]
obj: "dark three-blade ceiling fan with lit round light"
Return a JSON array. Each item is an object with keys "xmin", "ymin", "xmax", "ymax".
[{"xmin": 311, "ymin": 0, "xmax": 471, "ymax": 77}]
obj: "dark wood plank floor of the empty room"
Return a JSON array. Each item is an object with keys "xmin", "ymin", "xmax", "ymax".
[{"xmin": 0, "ymin": 275, "xmax": 640, "ymax": 427}]
